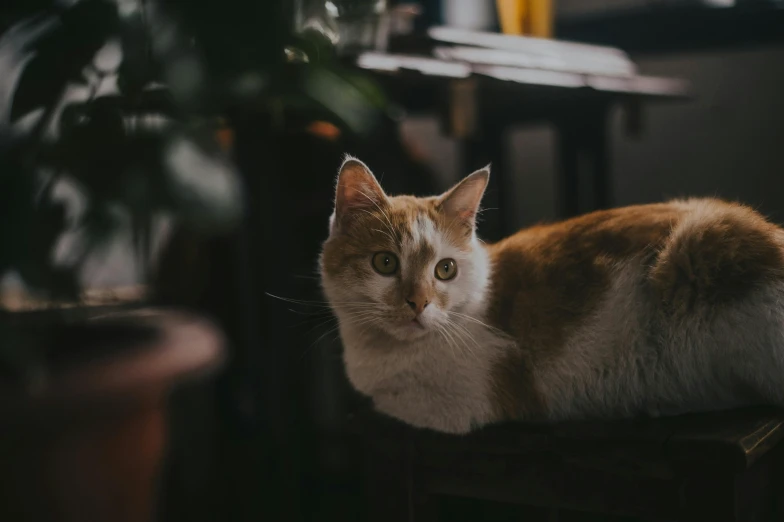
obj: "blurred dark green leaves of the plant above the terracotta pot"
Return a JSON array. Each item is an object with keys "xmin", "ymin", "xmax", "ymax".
[{"xmin": 0, "ymin": 0, "xmax": 386, "ymax": 380}]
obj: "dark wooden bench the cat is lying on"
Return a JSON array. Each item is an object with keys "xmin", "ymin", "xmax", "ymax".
[{"xmin": 356, "ymin": 408, "xmax": 784, "ymax": 522}]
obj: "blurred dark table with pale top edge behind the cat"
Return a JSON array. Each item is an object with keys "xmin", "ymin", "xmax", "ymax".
[{"xmin": 356, "ymin": 53, "xmax": 688, "ymax": 240}]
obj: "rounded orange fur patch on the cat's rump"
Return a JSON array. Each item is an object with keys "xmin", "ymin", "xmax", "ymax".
[{"xmin": 649, "ymin": 199, "xmax": 784, "ymax": 312}]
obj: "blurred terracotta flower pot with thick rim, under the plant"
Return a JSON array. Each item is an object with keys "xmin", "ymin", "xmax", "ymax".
[{"xmin": 0, "ymin": 310, "xmax": 222, "ymax": 522}]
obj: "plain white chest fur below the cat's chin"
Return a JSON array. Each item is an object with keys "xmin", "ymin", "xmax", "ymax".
[{"xmin": 341, "ymin": 321, "xmax": 508, "ymax": 433}]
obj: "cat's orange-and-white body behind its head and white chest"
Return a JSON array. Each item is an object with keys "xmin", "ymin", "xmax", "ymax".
[{"xmin": 487, "ymin": 199, "xmax": 784, "ymax": 418}]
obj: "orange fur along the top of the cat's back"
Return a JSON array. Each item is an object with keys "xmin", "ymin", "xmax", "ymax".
[{"xmin": 488, "ymin": 199, "xmax": 784, "ymax": 336}]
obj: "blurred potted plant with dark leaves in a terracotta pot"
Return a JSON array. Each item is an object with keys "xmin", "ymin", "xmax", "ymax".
[{"xmin": 0, "ymin": 0, "xmax": 398, "ymax": 521}]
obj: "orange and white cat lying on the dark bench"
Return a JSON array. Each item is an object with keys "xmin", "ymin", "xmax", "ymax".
[{"xmin": 321, "ymin": 158, "xmax": 784, "ymax": 433}]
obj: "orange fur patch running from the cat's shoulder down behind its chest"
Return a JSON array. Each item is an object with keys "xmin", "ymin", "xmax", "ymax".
[{"xmin": 489, "ymin": 204, "xmax": 683, "ymax": 419}]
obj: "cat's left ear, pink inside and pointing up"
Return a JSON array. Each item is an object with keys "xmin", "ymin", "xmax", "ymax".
[{"xmin": 334, "ymin": 156, "xmax": 387, "ymax": 224}]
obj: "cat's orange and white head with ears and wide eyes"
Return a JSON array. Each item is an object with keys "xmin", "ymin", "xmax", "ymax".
[{"xmin": 321, "ymin": 157, "xmax": 490, "ymax": 341}]
